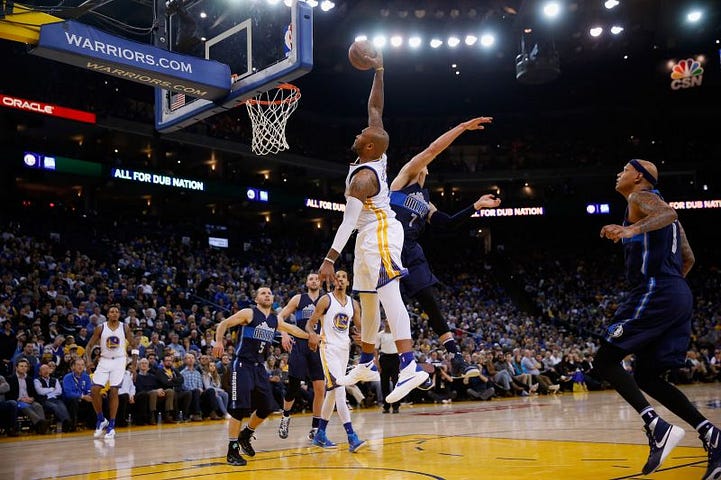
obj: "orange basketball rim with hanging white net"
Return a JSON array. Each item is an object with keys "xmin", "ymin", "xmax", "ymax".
[{"xmin": 245, "ymin": 83, "xmax": 300, "ymax": 155}]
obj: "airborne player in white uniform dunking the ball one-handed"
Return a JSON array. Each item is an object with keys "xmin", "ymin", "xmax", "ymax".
[{"xmin": 318, "ymin": 48, "xmax": 428, "ymax": 403}]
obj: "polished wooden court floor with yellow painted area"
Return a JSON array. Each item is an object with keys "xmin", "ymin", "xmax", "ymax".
[{"xmin": 0, "ymin": 384, "xmax": 721, "ymax": 480}]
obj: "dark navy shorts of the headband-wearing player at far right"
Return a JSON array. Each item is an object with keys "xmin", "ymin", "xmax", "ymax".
[{"xmin": 605, "ymin": 277, "xmax": 693, "ymax": 371}]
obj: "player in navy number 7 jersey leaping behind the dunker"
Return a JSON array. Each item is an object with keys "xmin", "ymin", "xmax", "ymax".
[{"xmin": 391, "ymin": 117, "xmax": 501, "ymax": 376}]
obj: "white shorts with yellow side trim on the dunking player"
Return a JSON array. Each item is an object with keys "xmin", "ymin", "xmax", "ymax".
[{"xmin": 353, "ymin": 218, "xmax": 408, "ymax": 293}]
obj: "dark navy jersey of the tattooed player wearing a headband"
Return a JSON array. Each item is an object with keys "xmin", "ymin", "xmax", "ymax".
[{"xmin": 623, "ymin": 190, "xmax": 683, "ymax": 286}]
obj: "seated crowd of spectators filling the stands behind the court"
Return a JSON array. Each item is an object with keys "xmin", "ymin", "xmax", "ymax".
[{"xmin": 0, "ymin": 216, "xmax": 721, "ymax": 435}]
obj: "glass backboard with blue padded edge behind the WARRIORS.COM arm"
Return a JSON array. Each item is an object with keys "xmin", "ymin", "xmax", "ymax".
[{"xmin": 155, "ymin": 0, "xmax": 313, "ymax": 132}]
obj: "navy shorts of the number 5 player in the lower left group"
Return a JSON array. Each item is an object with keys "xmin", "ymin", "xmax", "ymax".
[{"xmin": 228, "ymin": 360, "xmax": 274, "ymax": 411}]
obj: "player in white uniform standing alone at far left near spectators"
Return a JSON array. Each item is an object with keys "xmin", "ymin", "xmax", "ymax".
[{"xmin": 85, "ymin": 305, "xmax": 139, "ymax": 440}]
